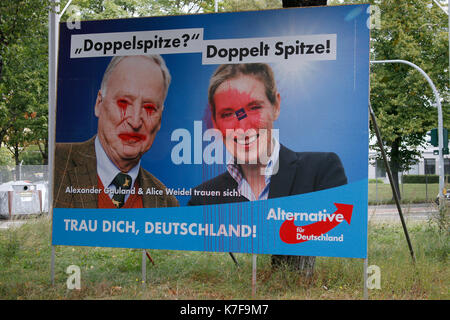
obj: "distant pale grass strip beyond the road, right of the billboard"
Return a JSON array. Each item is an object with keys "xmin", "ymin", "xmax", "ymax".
[{"xmin": 369, "ymin": 183, "xmax": 439, "ymax": 204}]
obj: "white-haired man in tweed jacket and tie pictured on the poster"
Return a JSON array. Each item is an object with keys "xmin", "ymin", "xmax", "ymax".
[{"xmin": 54, "ymin": 55, "xmax": 178, "ymax": 208}]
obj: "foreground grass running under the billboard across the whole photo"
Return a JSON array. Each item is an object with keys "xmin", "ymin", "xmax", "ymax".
[{"xmin": 0, "ymin": 217, "xmax": 450, "ymax": 300}]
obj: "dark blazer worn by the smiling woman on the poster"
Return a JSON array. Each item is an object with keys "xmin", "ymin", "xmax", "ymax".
[{"xmin": 188, "ymin": 145, "xmax": 347, "ymax": 205}]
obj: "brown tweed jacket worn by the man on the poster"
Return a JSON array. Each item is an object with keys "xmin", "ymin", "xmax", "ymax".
[{"xmin": 53, "ymin": 136, "xmax": 178, "ymax": 208}]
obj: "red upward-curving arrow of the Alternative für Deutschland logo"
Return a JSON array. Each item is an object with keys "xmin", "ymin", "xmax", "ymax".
[{"xmin": 280, "ymin": 203, "xmax": 353, "ymax": 244}]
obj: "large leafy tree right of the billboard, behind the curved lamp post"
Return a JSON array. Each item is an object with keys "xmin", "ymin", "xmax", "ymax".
[{"xmin": 333, "ymin": 0, "xmax": 450, "ymax": 199}]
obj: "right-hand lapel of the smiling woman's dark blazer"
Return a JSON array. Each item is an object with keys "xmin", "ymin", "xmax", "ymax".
[{"xmin": 269, "ymin": 145, "xmax": 297, "ymax": 199}]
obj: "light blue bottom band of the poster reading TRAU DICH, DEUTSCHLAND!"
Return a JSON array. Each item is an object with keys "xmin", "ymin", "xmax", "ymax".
[{"xmin": 53, "ymin": 182, "xmax": 367, "ymax": 258}]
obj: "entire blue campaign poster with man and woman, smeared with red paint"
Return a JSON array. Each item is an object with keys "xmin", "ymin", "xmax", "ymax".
[{"xmin": 52, "ymin": 5, "xmax": 369, "ymax": 258}]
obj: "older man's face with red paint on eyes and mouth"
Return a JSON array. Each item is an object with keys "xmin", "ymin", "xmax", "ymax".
[{"xmin": 95, "ymin": 57, "xmax": 164, "ymax": 172}]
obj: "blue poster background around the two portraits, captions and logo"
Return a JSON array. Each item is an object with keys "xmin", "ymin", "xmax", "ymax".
[{"xmin": 53, "ymin": 5, "xmax": 369, "ymax": 257}]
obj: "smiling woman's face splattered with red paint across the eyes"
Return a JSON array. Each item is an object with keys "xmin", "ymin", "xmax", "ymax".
[{"xmin": 213, "ymin": 75, "xmax": 280, "ymax": 164}]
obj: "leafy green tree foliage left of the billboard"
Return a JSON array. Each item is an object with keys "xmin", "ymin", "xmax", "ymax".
[{"xmin": 0, "ymin": 1, "xmax": 48, "ymax": 164}]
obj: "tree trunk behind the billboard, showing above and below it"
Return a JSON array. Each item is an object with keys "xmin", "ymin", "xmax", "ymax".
[{"xmin": 272, "ymin": 0, "xmax": 327, "ymax": 279}]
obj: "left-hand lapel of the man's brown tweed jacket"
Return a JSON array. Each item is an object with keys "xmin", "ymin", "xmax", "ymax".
[{"xmin": 68, "ymin": 136, "xmax": 98, "ymax": 208}]
